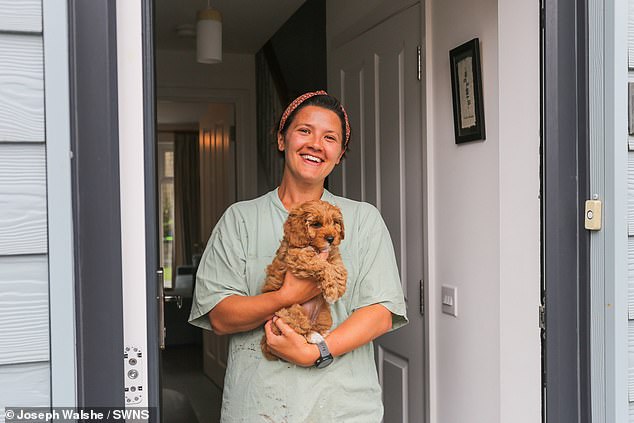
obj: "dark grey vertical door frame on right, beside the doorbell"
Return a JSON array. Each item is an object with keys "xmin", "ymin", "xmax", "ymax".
[{"xmin": 541, "ymin": 0, "xmax": 591, "ymax": 423}]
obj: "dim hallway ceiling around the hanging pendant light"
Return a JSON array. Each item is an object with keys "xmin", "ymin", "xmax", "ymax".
[{"xmin": 154, "ymin": 0, "xmax": 305, "ymax": 54}]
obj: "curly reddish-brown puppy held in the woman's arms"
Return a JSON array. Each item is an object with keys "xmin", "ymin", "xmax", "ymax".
[{"xmin": 261, "ymin": 200, "xmax": 348, "ymax": 360}]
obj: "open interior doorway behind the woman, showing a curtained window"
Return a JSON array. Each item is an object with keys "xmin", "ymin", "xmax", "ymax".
[{"xmin": 155, "ymin": 98, "xmax": 237, "ymax": 423}]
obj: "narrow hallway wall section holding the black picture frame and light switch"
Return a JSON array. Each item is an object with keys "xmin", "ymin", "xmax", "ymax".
[{"xmin": 426, "ymin": 0, "xmax": 500, "ymax": 423}]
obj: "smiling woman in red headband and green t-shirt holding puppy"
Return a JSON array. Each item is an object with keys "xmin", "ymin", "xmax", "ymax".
[{"xmin": 190, "ymin": 91, "xmax": 407, "ymax": 423}]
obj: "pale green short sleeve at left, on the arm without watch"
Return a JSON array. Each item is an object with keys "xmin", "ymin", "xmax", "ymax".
[{"xmin": 189, "ymin": 207, "xmax": 248, "ymax": 330}]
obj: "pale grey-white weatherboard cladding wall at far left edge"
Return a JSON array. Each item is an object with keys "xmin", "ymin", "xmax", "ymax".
[{"xmin": 0, "ymin": 0, "xmax": 51, "ymax": 422}]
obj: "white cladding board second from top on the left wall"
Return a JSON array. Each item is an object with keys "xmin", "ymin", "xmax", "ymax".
[{"xmin": 0, "ymin": 33, "xmax": 44, "ymax": 142}]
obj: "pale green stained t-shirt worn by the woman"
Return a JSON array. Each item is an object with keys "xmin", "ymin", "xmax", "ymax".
[{"xmin": 190, "ymin": 189, "xmax": 407, "ymax": 423}]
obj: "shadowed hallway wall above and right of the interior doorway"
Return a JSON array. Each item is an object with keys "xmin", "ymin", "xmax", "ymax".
[{"xmin": 156, "ymin": 50, "xmax": 257, "ymax": 199}]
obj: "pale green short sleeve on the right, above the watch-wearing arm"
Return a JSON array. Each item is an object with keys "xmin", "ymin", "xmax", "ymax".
[{"xmin": 352, "ymin": 204, "xmax": 408, "ymax": 330}]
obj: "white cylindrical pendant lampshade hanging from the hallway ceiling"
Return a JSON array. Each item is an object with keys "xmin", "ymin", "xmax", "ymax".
[{"xmin": 196, "ymin": 8, "xmax": 222, "ymax": 63}]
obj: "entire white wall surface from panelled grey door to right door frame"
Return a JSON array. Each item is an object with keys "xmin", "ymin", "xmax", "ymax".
[{"xmin": 426, "ymin": 0, "xmax": 541, "ymax": 423}]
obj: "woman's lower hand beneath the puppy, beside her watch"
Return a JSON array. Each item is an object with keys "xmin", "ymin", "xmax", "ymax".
[{"xmin": 264, "ymin": 317, "xmax": 319, "ymax": 367}]
